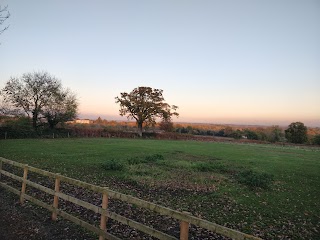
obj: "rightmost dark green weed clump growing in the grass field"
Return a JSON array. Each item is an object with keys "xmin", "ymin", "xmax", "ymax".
[{"xmin": 236, "ymin": 170, "xmax": 273, "ymax": 189}]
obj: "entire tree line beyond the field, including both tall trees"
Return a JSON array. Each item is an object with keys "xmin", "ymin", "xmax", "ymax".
[{"xmin": 0, "ymin": 72, "xmax": 320, "ymax": 145}]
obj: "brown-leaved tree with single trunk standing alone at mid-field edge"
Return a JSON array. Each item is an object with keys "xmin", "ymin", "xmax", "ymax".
[{"xmin": 116, "ymin": 87, "xmax": 179, "ymax": 136}]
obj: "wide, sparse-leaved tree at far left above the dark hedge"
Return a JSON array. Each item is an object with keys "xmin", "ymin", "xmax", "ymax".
[{"xmin": 2, "ymin": 72, "xmax": 78, "ymax": 128}]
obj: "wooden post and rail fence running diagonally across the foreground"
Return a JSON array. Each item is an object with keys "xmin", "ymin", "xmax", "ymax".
[{"xmin": 0, "ymin": 157, "xmax": 261, "ymax": 240}]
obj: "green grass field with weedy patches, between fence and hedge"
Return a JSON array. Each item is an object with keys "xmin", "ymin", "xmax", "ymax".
[{"xmin": 0, "ymin": 138, "xmax": 320, "ymax": 239}]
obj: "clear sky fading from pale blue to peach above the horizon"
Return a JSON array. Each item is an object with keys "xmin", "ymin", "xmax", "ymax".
[{"xmin": 0, "ymin": 0, "xmax": 320, "ymax": 127}]
